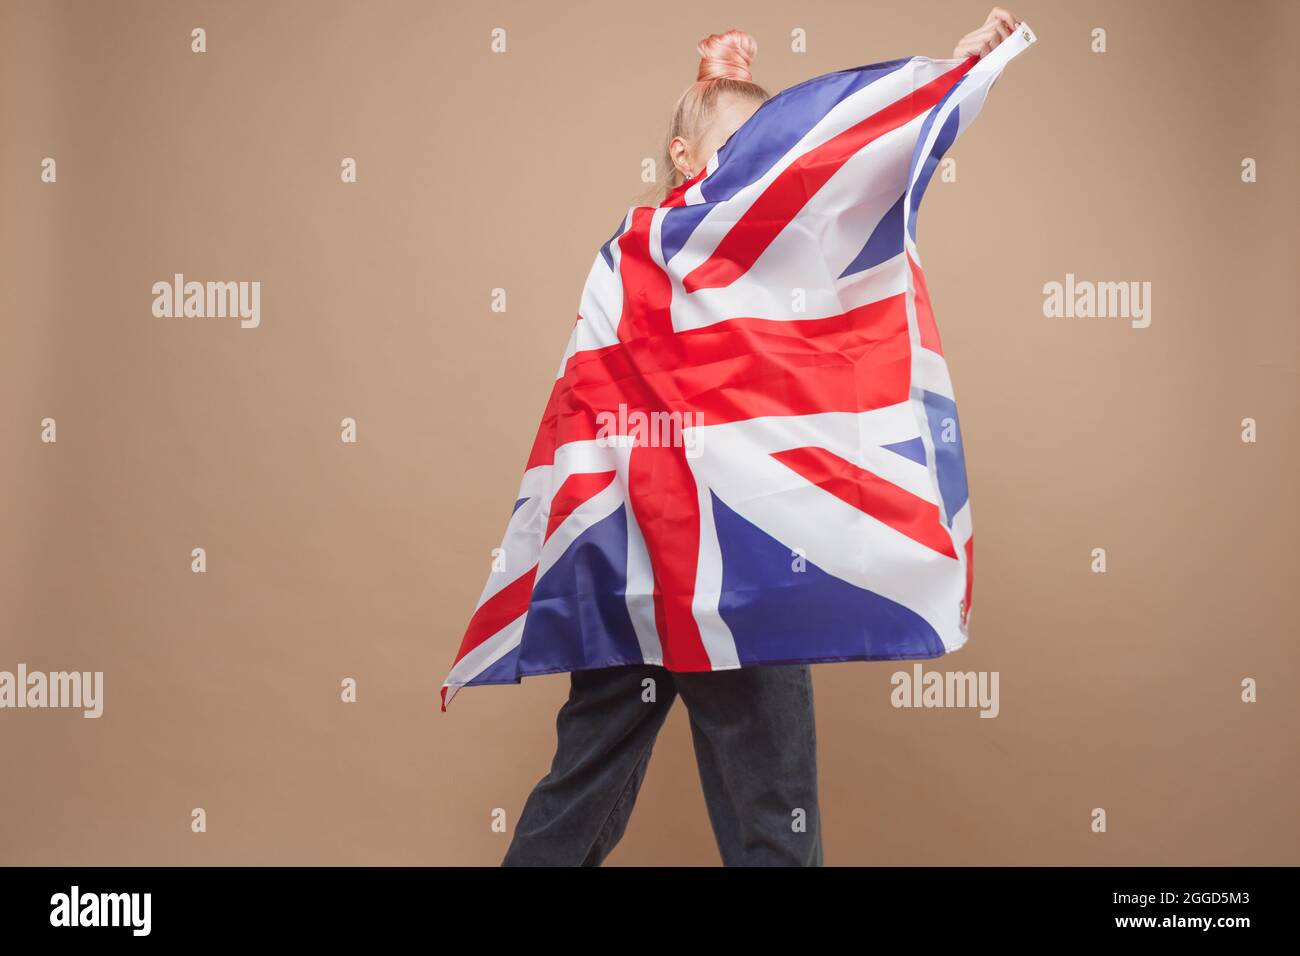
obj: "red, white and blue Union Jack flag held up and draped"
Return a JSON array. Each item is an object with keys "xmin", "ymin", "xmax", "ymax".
[{"xmin": 442, "ymin": 23, "xmax": 1035, "ymax": 709}]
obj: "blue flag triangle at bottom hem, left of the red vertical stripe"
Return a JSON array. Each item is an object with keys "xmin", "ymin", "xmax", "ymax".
[{"xmin": 512, "ymin": 505, "xmax": 641, "ymax": 679}]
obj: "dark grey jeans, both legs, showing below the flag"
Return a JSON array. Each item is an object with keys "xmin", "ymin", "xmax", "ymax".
[{"xmin": 502, "ymin": 665, "xmax": 822, "ymax": 866}]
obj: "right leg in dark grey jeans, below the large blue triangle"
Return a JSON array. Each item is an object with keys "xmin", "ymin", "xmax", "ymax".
[{"xmin": 672, "ymin": 666, "xmax": 822, "ymax": 866}]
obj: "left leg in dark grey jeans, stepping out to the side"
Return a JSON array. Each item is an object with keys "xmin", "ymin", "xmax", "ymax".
[{"xmin": 502, "ymin": 666, "xmax": 676, "ymax": 866}]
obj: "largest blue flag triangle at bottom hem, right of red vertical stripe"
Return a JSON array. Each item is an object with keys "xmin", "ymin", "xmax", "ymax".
[{"xmin": 712, "ymin": 494, "xmax": 944, "ymax": 665}]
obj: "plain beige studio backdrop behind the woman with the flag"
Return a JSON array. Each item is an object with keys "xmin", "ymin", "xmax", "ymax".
[{"xmin": 0, "ymin": 0, "xmax": 1300, "ymax": 864}]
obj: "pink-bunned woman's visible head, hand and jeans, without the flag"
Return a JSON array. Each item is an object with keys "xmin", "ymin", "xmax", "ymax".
[{"xmin": 491, "ymin": 8, "xmax": 1017, "ymax": 866}]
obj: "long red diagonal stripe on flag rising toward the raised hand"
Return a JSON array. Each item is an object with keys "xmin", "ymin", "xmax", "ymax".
[{"xmin": 681, "ymin": 57, "xmax": 978, "ymax": 293}]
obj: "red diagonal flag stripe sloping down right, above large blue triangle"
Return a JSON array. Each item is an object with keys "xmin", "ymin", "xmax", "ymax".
[{"xmin": 772, "ymin": 447, "xmax": 957, "ymax": 561}]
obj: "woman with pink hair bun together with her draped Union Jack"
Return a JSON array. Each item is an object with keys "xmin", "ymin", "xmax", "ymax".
[{"xmin": 443, "ymin": 8, "xmax": 1032, "ymax": 866}]
